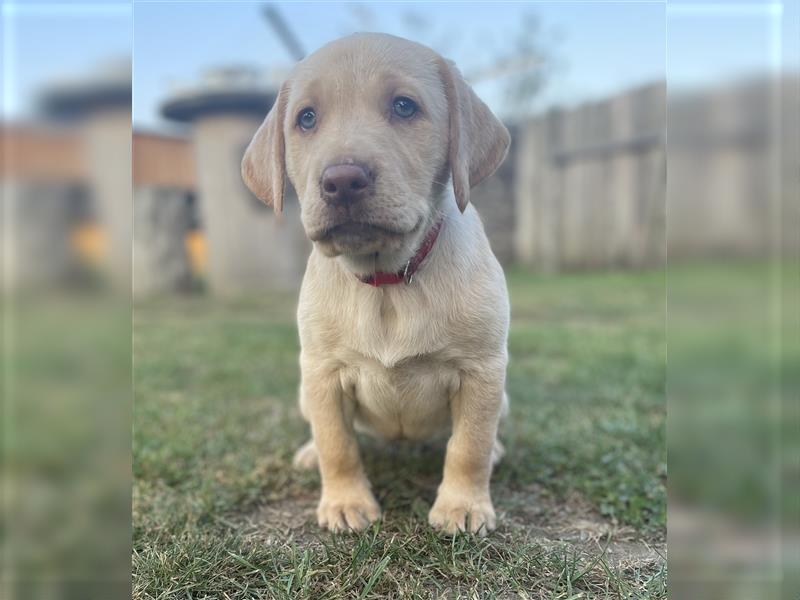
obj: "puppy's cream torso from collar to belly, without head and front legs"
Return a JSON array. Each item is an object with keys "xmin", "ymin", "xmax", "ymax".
[{"xmin": 298, "ymin": 195, "xmax": 508, "ymax": 440}]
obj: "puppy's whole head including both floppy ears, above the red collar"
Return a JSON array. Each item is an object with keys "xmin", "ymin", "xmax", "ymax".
[{"xmin": 242, "ymin": 34, "xmax": 509, "ymax": 267}]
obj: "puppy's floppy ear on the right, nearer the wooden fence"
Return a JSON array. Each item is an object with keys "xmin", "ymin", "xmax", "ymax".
[{"xmin": 439, "ymin": 58, "xmax": 511, "ymax": 212}]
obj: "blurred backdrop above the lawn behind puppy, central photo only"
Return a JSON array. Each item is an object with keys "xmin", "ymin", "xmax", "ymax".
[{"xmin": 133, "ymin": 3, "xmax": 665, "ymax": 296}]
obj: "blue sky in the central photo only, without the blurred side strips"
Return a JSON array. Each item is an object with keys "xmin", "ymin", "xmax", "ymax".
[{"xmin": 134, "ymin": 2, "xmax": 665, "ymax": 126}]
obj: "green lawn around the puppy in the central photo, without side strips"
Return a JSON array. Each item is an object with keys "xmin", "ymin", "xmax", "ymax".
[{"xmin": 133, "ymin": 271, "xmax": 666, "ymax": 600}]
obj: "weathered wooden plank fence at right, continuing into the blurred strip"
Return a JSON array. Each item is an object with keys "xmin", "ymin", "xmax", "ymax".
[{"xmin": 510, "ymin": 73, "xmax": 800, "ymax": 270}]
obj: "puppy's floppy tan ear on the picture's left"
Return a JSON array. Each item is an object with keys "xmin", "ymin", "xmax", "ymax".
[{"xmin": 242, "ymin": 83, "xmax": 289, "ymax": 213}]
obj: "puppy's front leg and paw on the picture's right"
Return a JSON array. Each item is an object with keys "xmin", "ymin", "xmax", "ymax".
[{"xmin": 428, "ymin": 364, "xmax": 505, "ymax": 535}]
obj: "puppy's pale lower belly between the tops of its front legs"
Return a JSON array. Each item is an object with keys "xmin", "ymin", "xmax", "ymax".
[{"xmin": 342, "ymin": 357, "xmax": 459, "ymax": 440}]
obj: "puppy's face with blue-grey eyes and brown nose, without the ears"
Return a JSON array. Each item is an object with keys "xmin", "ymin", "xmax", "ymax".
[{"xmin": 284, "ymin": 37, "xmax": 448, "ymax": 256}]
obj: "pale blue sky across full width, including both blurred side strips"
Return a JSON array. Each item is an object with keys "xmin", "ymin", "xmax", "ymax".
[{"xmin": 0, "ymin": 0, "xmax": 800, "ymax": 130}]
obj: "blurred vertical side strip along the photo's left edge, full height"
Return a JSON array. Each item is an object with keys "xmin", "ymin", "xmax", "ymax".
[{"xmin": 0, "ymin": 0, "xmax": 133, "ymax": 599}]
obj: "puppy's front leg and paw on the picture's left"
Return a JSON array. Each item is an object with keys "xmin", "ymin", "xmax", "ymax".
[{"xmin": 301, "ymin": 365, "xmax": 381, "ymax": 531}]
